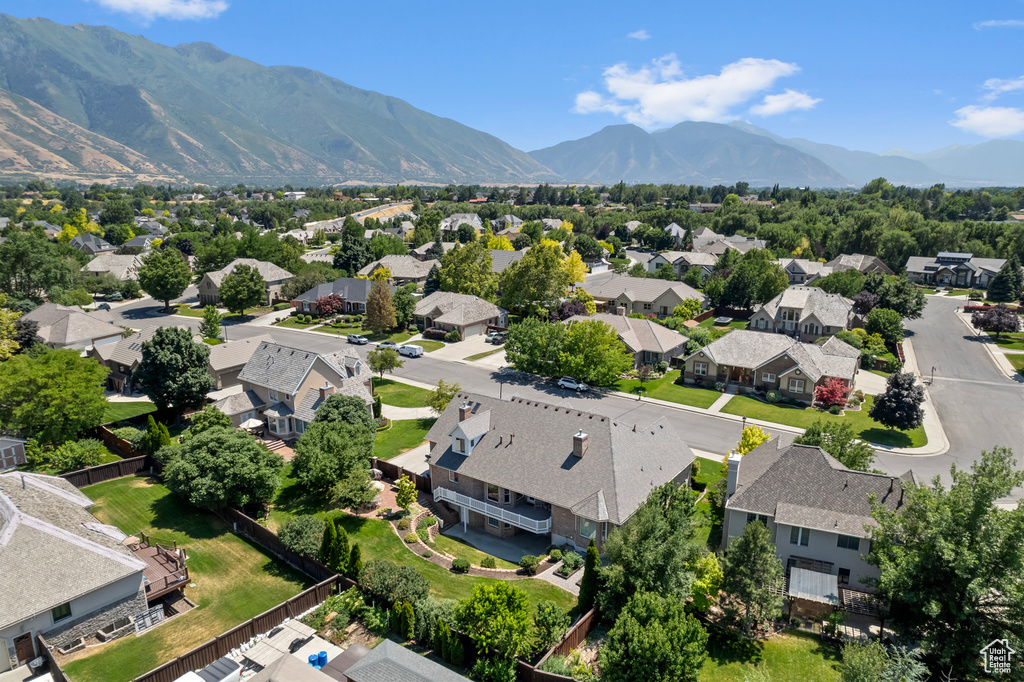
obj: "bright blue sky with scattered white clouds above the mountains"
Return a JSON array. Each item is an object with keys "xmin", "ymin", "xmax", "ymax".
[{"xmin": 14, "ymin": 0, "xmax": 1024, "ymax": 152}]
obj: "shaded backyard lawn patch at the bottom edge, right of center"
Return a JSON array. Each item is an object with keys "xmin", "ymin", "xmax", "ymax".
[{"xmin": 699, "ymin": 631, "xmax": 842, "ymax": 682}]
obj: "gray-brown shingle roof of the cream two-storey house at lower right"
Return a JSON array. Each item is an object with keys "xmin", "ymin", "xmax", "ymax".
[{"xmin": 726, "ymin": 438, "xmax": 913, "ymax": 538}]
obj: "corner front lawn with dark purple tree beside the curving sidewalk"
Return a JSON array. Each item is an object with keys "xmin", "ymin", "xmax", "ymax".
[{"xmin": 722, "ymin": 395, "xmax": 928, "ymax": 447}]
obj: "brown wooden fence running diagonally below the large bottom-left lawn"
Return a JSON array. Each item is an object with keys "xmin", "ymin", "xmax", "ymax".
[{"xmin": 134, "ymin": 576, "xmax": 355, "ymax": 682}]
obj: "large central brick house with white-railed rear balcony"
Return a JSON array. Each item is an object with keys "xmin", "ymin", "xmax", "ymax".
[{"xmin": 427, "ymin": 392, "xmax": 693, "ymax": 551}]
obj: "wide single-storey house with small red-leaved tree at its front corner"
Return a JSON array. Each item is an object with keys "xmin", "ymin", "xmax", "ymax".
[{"xmin": 683, "ymin": 330, "xmax": 860, "ymax": 403}]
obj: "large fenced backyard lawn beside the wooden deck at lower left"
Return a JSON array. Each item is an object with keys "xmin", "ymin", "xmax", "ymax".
[{"xmin": 65, "ymin": 477, "xmax": 311, "ymax": 682}]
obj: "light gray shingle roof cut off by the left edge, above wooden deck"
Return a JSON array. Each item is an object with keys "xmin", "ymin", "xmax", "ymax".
[{"xmin": 0, "ymin": 472, "xmax": 145, "ymax": 630}]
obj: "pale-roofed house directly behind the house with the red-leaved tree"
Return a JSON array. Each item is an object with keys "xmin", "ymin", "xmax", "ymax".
[{"xmin": 749, "ymin": 287, "xmax": 863, "ymax": 342}]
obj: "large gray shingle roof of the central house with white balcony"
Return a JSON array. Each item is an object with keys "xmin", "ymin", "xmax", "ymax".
[{"xmin": 427, "ymin": 392, "xmax": 693, "ymax": 523}]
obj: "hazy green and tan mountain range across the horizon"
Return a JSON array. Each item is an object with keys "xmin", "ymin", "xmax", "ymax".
[{"xmin": 0, "ymin": 14, "xmax": 1024, "ymax": 187}]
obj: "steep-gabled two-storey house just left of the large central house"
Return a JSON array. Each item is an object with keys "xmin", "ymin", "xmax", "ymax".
[{"xmin": 234, "ymin": 341, "xmax": 373, "ymax": 439}]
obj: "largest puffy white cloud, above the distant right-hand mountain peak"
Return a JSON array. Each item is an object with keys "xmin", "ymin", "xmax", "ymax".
[{"xmin": 573, "ymin": 54, "xmax": 806, "ymax": 127}]
